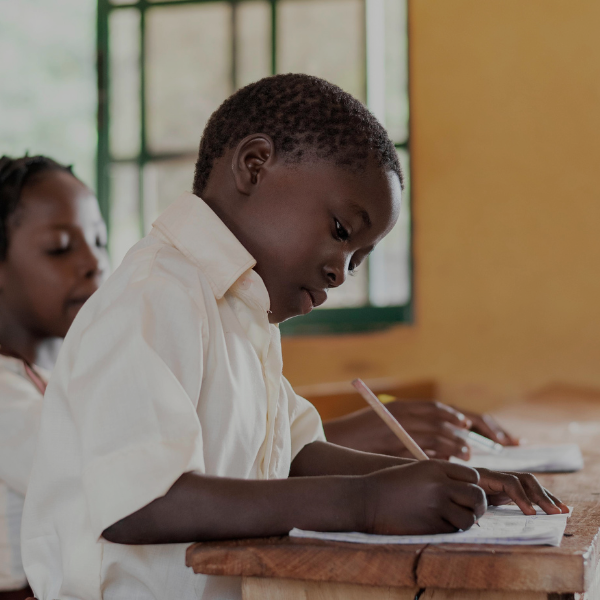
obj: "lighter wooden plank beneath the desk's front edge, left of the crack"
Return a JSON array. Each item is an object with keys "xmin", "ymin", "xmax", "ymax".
[{"xmin": 242, "ymin": 577, "xmax": 414, "ymax": 600}]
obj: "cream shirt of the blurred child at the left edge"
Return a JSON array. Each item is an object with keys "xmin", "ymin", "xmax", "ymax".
[{"xmin": 0, "ymin": 355, "xmax": 49, "ymax": 591}]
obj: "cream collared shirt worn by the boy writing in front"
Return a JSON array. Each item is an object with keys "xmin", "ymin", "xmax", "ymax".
[{"xmin": 22, "ymin": 194, "xmax": 324, "ymax": 600}]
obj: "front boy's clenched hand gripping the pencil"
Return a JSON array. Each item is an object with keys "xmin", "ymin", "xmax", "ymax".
[{"xmin": 364, "ymin": 460, "xmax": 487, "ymax": 535}]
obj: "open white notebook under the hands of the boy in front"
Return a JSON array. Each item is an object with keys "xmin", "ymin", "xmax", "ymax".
[{"xmin": 290, "ymin": 505, "xmax": 572, "ymax": 546}]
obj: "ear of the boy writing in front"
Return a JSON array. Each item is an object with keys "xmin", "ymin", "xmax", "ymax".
[{"xmin": 231, "ymin": 133, "xmax": 275, "ymax": 196}]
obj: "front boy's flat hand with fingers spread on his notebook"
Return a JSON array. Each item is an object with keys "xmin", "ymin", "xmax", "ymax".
[{"xmin": 476, "ymin": 469, "xmax": 569, "ymax": 515}]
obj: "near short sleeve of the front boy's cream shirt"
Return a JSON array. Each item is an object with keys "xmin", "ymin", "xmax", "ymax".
[{"xmin": 67, "ymin": 277, "xmax": 206, "ymax": 537}]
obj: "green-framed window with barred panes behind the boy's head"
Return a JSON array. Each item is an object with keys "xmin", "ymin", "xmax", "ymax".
[{"xmin": 97, "ymin": 0, "xmax": 412, "ymax": 334}]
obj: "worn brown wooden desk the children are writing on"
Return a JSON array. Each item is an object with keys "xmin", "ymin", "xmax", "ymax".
[{"xmin": 187, "ymin": 397, "xmax": 600, "ymax": 600}]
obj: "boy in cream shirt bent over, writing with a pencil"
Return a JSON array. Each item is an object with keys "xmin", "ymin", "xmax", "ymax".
[{"xmin": 23, "ymin": 75, "xmax": 563, "ymax": 600}]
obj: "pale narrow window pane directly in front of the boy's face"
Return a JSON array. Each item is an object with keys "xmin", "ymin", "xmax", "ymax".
[{"xmin": 369, "ymin": 150, "xmax": 411, "ymax": 306}]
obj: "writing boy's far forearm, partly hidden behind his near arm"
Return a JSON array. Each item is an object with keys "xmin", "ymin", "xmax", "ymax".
[{"xmin": 290, "ymin": 442, "xmax": 414, "ymax": 477}]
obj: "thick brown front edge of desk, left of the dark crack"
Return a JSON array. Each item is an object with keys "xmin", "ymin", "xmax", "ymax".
[{"xmin": 186, "ymin": 536, "xmax": 425, "ymax": 587}]
